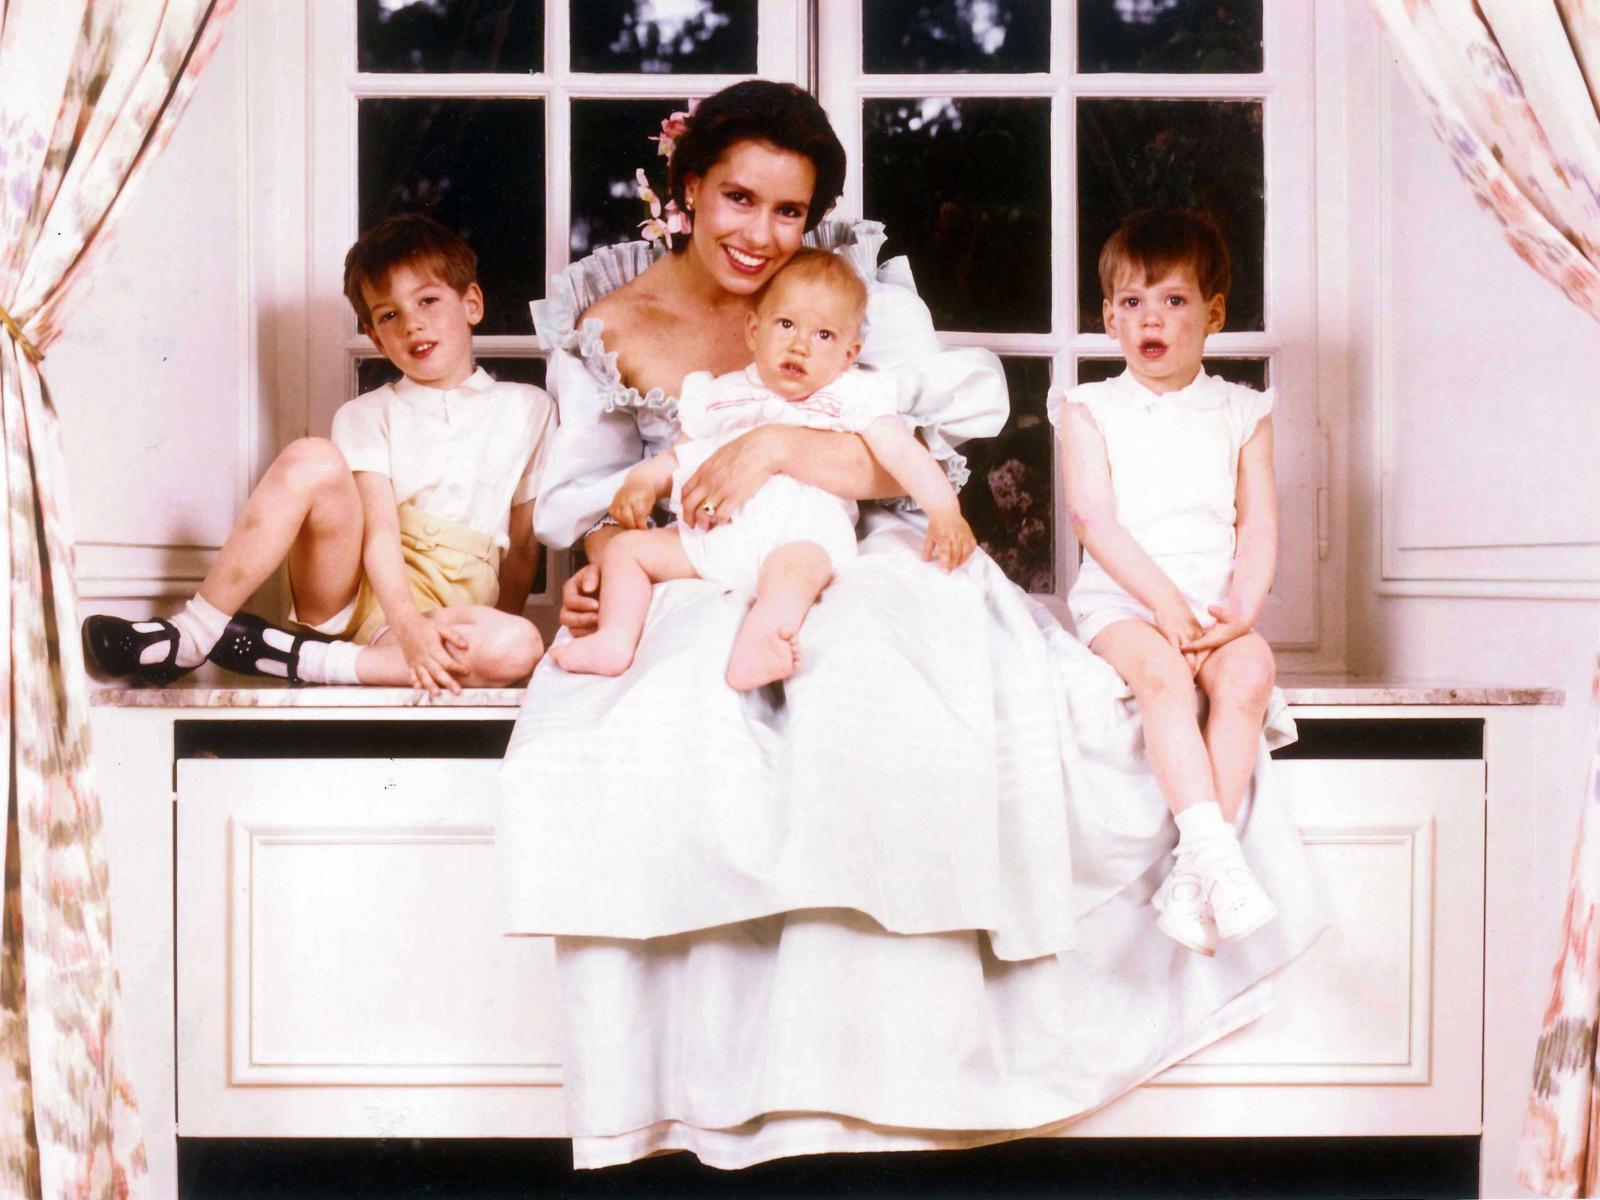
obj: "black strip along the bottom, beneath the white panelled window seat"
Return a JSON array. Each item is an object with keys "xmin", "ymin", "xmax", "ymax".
[{"xmin": 178, "ymin": 1138, "xmax": 1478, "ymax": 1200}]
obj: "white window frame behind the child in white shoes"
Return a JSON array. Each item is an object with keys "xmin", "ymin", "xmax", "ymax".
[{"xmin": 818, "ymin": 0, "xmax": 1339, "ymax": 666}]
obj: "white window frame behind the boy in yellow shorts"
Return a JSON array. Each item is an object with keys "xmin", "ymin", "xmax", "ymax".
[{"xmin": 297, "ymin": 0, "xmax": 813, "ymax": 624}]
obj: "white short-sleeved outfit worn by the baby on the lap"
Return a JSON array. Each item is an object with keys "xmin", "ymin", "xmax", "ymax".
[{"xmin": 672, "ymin": 365, "xmax": 898, "ymax": 592}]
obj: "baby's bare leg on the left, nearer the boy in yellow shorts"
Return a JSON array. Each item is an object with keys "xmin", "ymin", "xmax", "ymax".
[{"xmin": 550, "ymin": 530, "xmax": 696, "ymax": 675}]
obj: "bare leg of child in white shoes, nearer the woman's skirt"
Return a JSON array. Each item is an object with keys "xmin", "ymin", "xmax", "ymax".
[{"xmin": 1090, "ymin": 619, "xmax": 1216, "ymax": 814}]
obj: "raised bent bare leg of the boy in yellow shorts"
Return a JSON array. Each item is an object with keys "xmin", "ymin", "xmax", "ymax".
[{"xmin": 200, "ymin": 437, "xmax": 365, "ymax": 624}]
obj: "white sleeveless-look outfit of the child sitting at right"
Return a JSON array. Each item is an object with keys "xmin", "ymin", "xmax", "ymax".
[{"xmin": 1046, "ymin": 371, "xmax": 1274, "ymax": 643}]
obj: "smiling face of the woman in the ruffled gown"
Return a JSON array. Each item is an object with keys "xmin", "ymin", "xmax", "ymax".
[{"xmin": 683, "ymin": 141, "xmax": 816, "ymax": 296}]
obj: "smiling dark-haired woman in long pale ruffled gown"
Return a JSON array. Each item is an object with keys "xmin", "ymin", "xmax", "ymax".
[{"xmin": 499, "ymin": 82, "xmax": 1317, "ymax": 1166}]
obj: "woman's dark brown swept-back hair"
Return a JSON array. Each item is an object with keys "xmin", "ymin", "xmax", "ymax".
[{"xmin": 667, "ymin": 78, "xmax": 845, "ymax": 250}]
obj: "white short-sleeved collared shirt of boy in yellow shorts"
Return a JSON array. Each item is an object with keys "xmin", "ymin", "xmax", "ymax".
[{"xmin": 333, "ymin": 366, "xmax": 555, "ymax": 549}]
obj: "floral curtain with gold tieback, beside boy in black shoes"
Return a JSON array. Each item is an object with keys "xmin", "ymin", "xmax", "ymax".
[{"xmin": 0, "ymin": 0, "xmax": 232, "ymax": 1197}]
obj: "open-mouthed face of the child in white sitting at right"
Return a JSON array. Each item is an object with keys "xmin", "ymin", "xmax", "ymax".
[{"xmin": 1101, "ymin": 267, "xmax": 1227, "ymax": 392}]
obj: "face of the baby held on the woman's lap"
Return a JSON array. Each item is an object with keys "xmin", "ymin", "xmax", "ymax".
[{"xmin": 746, "ymin": 272, "xmax": 861, "ymax": 400}]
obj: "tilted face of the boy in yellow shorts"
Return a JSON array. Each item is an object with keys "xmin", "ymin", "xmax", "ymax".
[{"xmin": 362, "ymin": 264, "xmax": 483, "ymax": 387}]
